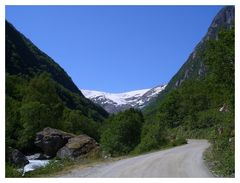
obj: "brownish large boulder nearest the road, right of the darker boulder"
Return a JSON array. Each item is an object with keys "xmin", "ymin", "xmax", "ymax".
[{"xmin": 57, "ymin": 134, "xmax": 99, "ymax": 159}]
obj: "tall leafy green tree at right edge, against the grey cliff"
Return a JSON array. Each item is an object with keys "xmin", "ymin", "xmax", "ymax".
[{"xmin": 204, "ymin": 28, "xmax": 235, "ymax": 91}]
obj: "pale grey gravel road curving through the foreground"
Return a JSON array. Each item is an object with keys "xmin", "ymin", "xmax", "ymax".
[{"xmin": 60, "ymin": 140, "xmax": 213, "ymax": 178}]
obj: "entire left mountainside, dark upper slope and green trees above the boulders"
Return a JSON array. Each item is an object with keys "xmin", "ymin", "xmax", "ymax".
[{"xmin": 5, "ymin": 21, "xmax": 108, "ymax": 150}]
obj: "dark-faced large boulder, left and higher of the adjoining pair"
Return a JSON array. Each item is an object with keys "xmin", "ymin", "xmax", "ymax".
[{"xmin": 34, "ymin": 127, "xmax": 75, "ymax": 157}]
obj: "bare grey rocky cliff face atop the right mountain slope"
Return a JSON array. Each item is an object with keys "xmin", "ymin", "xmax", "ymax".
[{"xmin": 145, "ymin": 6, "xmax": 235, "ymax": 115}]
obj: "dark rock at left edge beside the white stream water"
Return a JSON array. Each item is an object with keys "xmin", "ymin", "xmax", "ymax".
[{"xmin": 6, "ymin": 147, "xmax": 29, "ymax": 166}]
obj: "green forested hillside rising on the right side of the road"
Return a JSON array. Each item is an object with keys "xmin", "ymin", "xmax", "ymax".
[{"xmin": 141, "ymin": 7, "xmax": 235, "ymax": 176}]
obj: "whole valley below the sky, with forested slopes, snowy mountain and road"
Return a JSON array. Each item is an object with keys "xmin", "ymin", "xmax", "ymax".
[{"xmin": 5, "ymin": 6, "xmax": 235, "ymax": 178}]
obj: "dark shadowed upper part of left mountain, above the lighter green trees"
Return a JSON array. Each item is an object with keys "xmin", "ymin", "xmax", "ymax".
[{"xmin": 6, "ymin": 22, "xmax": 81, "ymax": 95}]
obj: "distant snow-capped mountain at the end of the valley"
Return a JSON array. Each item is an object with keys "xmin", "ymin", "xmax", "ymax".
[{"xmin": 81, "ymin": 85, "xmax": 166, "ymax": 113}]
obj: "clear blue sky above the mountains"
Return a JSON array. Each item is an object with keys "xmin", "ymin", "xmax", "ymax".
[{"xmin": 6, "ymin": 6, "xmax": 222, "ymax": 92}]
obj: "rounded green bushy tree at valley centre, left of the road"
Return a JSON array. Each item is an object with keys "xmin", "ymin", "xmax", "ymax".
[{"xmin": 100, "ymin": 109, "xmax": 144, "ymax": 155}]
